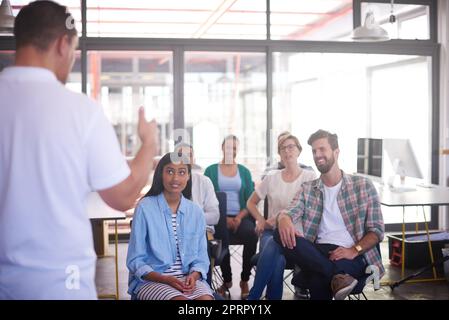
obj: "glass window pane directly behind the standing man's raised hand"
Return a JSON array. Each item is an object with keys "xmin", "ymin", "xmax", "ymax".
[{"xmin": 87, "ymin": 51, "xmax": 173, "ymax": 157}]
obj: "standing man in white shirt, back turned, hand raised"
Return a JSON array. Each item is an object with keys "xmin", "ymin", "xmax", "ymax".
[{"xmin": 0, "ymin": 1, "xmax": 158, "ymax": 299}]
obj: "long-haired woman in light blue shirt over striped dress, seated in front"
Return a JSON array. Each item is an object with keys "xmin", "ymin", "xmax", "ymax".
[{"xmin": 126, "ymin": 153, "xmax": 213, "ymax": 300}]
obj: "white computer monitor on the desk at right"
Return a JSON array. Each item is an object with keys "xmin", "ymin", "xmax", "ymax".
[{"xmin": 383, "ymin": 139, "xmax": 423, "ymax": 182}]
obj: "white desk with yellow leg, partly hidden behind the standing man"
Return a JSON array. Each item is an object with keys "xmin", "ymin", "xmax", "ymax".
[{"xmin": 87, "ymin": 192, "xmax": 126, "ymax": 300}]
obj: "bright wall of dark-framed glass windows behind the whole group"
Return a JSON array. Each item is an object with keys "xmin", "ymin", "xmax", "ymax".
[{"xmin": 0, "ymin": 0, "xmax": 449, "ymax": 298}]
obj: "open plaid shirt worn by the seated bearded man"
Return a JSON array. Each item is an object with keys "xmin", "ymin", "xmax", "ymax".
[{"xmin": 282, "ymin": 171, "xmax": 385, "ymax": 277}]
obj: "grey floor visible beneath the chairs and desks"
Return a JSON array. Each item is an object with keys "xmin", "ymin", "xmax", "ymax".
[{"xmin": 96, "ymin": 241, "xmax": 449, "ymax": 300}]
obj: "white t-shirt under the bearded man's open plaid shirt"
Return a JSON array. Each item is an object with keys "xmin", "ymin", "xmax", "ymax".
[{"xmin": 316, "ymin": 180, "xmax": 354, "ymax": 248}]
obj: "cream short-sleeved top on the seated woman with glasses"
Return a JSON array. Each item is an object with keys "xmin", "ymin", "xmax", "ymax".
[{"xmin": 256, "ymin": 170, "xmax": 316, "ymax": 218}]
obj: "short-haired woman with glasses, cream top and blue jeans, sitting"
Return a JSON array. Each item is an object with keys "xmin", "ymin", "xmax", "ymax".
[{"xmin": 247, "ymin": 134, "xmax": 316, "ymax": 300}]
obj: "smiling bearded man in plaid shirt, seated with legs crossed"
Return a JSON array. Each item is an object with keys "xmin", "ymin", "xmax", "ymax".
[{"xmin": 274, "ymin": 130, "xmax": 384, "ymax": 300}]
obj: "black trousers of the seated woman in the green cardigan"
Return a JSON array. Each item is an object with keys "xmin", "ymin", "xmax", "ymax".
[{"xmin": 220, "ymin": 216, "xmax": 258, "ymax": 282}]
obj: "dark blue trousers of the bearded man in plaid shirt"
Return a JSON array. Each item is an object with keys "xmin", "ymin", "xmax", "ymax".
[{"xmin": 273, "ymin": 230, "xmax": 366, "ymax": 300}]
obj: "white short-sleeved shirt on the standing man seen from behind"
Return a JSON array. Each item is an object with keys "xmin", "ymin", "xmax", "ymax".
[{"xmin": 0, "ymin": 67, "xmax": 130, "ymax": 300}]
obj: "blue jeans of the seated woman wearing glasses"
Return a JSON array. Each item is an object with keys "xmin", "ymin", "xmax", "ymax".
[{"xmin": 248, "ymin": 230, "xmax": 286, "ymax": 300}]
